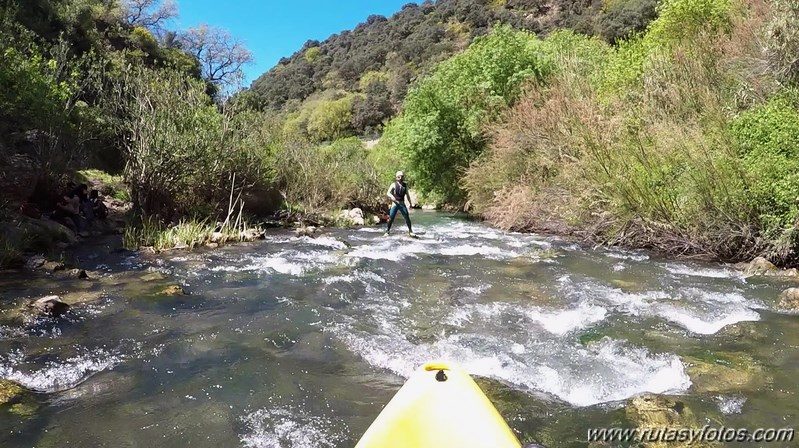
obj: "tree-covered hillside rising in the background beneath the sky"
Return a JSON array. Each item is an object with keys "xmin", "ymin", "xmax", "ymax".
[{"xmin": 250, "ymin": 0, "xmax": 657, "ymax": 141}]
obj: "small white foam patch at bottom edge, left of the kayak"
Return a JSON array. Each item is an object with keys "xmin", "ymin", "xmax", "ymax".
[{"xmin": 240, "ymin": 405, "xmax": 345, "ymax": 448}]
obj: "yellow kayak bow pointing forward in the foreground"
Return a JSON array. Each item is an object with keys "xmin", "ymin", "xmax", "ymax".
[{"xmin": 355, "ymin": 362, "xmax": 521, "ymax": 448}]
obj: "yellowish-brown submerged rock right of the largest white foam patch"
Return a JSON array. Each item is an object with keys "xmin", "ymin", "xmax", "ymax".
[{"xmin": 683, "ymin": 351, "xmax": 770, "ymax": 393}]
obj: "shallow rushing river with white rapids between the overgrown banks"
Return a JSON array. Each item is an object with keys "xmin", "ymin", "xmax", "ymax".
[{"xmin": 0, "ymin": 212, "xmax": 799, "ymax": 448}]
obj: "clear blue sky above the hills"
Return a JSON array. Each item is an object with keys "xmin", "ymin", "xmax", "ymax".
[{"xmin": 173, "ymin": 0, "xmax": 412, "ymax": 86}]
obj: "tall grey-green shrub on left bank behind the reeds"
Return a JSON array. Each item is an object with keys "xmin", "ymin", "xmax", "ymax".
[{"xmin": 111, "ymin": 67, "xmax": 279, "ymax": 218}]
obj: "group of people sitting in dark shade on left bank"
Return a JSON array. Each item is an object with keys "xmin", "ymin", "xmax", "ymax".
[{"xmin": 51, "ymin": 182, "xmax": 108, "ymax": 234}]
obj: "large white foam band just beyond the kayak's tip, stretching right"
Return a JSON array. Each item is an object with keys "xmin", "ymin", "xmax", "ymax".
[{"xmin": 332, "ymin": 328, "xmax": 691, "ymax": 406}]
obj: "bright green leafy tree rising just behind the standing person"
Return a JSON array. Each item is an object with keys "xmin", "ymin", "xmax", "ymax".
[{"xmin": 384, "ymin": 26, "xmax": 552, "ymax": 203}]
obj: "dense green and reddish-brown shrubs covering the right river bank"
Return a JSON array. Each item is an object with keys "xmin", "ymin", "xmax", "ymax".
[{"xmin": 463, "ymin": 0, "xmax": 799, "ymax": 264}]
